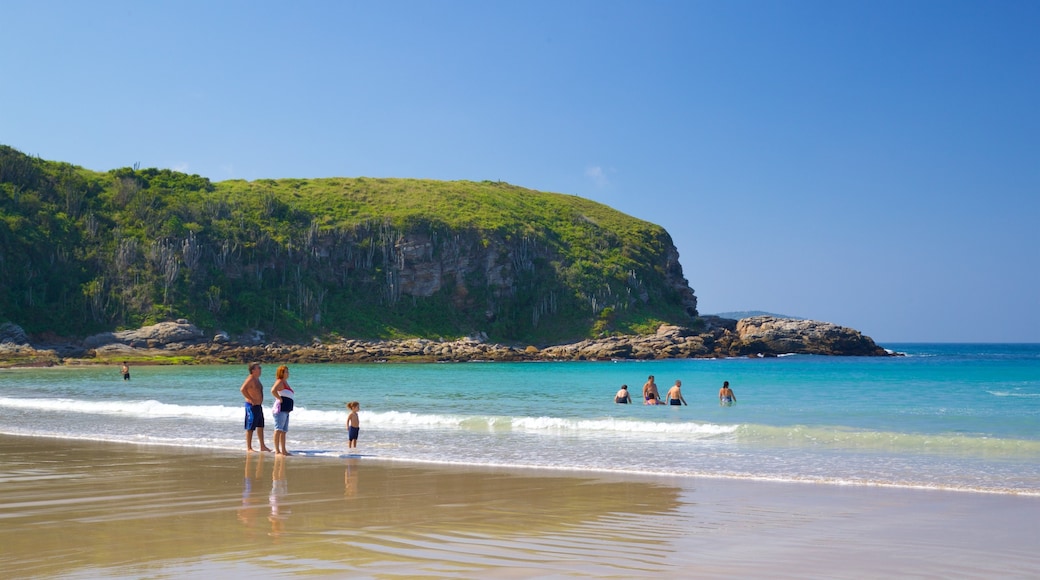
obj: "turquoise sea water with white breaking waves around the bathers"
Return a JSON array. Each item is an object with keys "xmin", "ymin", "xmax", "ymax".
[{"xmin": 0, "ymin": 344, "xmax": 1040, "ymax": 495}]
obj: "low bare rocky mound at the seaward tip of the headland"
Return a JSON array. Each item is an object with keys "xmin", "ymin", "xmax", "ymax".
[{"xmin": 731, "ymin": 316, "xmax": 888, "ymax": 357}]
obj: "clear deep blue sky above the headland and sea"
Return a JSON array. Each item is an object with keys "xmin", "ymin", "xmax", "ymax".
[{"xmin": 0, "ymin": 0, "xmax": 1040, "ymax": 343}]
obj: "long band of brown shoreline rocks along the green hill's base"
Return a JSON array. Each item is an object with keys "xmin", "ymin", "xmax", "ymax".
[{"xmin": 0, "ymin": 316, "xmax": 891, "ymax": 366}]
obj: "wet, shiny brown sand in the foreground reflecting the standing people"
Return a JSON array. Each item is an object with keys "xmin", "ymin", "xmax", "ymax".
[{"xmin": 0, "ymin": 436, "xmax": 1040, "ymax": 578}]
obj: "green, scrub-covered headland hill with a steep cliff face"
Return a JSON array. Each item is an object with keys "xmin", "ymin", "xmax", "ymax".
[{"xmin": 0, "ymin": 146, "xmax": 697, "ymax": 344}]
